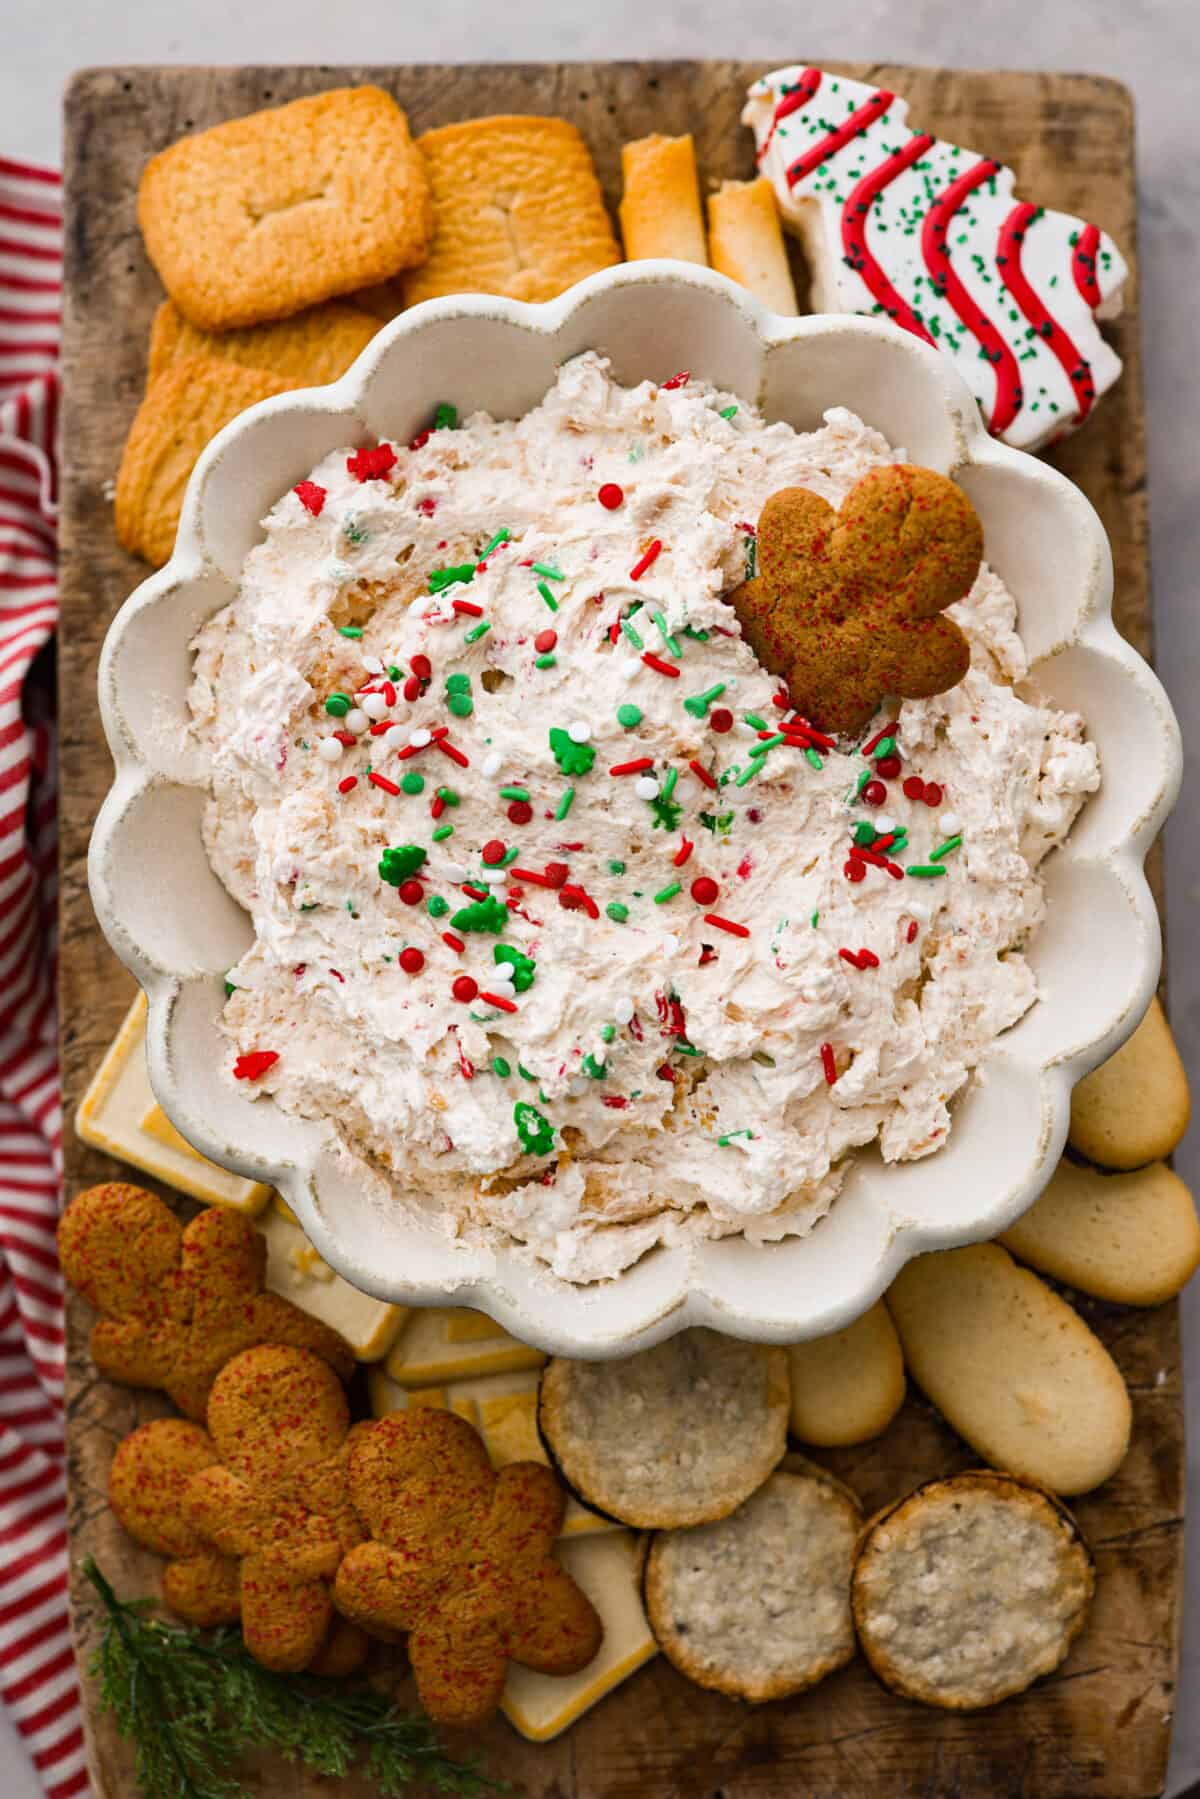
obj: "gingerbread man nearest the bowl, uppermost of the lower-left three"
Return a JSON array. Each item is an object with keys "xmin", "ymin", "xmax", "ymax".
[{"xmin": 58, "ymin": 1182, "xmax": 354, "ymax": 1419}]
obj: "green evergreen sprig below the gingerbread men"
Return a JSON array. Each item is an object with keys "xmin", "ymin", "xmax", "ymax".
[{"xmin": 83, "ymin": 1556, "xmax": 511, "ymax": 1799}]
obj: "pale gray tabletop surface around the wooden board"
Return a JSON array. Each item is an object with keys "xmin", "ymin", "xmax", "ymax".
[{"xmin": 0, "ymin": 0, "xmax": 1200, "ymax": 1799}]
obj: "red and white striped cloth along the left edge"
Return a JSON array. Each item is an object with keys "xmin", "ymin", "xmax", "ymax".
[{"xmin": 0, "ymin": 158, "xmax": 88, "ymax": 1799}]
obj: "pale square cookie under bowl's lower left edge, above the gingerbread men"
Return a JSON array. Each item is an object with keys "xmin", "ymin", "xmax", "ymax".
[{"xmin": 76, "ymin": 993, "xmax": 272, "ymax": 1213}]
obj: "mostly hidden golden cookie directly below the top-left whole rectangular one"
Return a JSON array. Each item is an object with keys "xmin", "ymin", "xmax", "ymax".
[{"xmin": 146, "ymin": 300, "xmax": 380, "ymax": 387}]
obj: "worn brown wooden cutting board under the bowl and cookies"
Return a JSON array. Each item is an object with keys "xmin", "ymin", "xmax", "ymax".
[{"xmin": 59, "ymin": 50, "xmax": 1184, "ymax": 1799}]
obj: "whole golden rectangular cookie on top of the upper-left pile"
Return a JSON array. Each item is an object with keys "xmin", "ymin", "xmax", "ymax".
[{"xmin": 137, "ymin": 86, "xmax": 434, "ymax": 331}]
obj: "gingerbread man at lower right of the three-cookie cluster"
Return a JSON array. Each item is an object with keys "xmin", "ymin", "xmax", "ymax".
[{"xmin": 335, "ymin": 1410, "xmax": 603, "ymax": 1723}]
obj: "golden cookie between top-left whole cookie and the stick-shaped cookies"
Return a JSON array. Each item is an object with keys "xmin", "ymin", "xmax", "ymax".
[{"xmin": 403, "ymin": 115, "xmax": 621, "ymax": 306}]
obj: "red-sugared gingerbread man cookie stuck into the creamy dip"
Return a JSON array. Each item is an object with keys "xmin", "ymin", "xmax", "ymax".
[{"xmin": 729, "ymin": 462, "xmax": 984, "ymax": 734}]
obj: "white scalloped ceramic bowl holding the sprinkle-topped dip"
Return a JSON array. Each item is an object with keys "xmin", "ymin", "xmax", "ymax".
[{"xmin": 88, "ymin": 263, "xmax": 1180, "ymax": 1356}]
